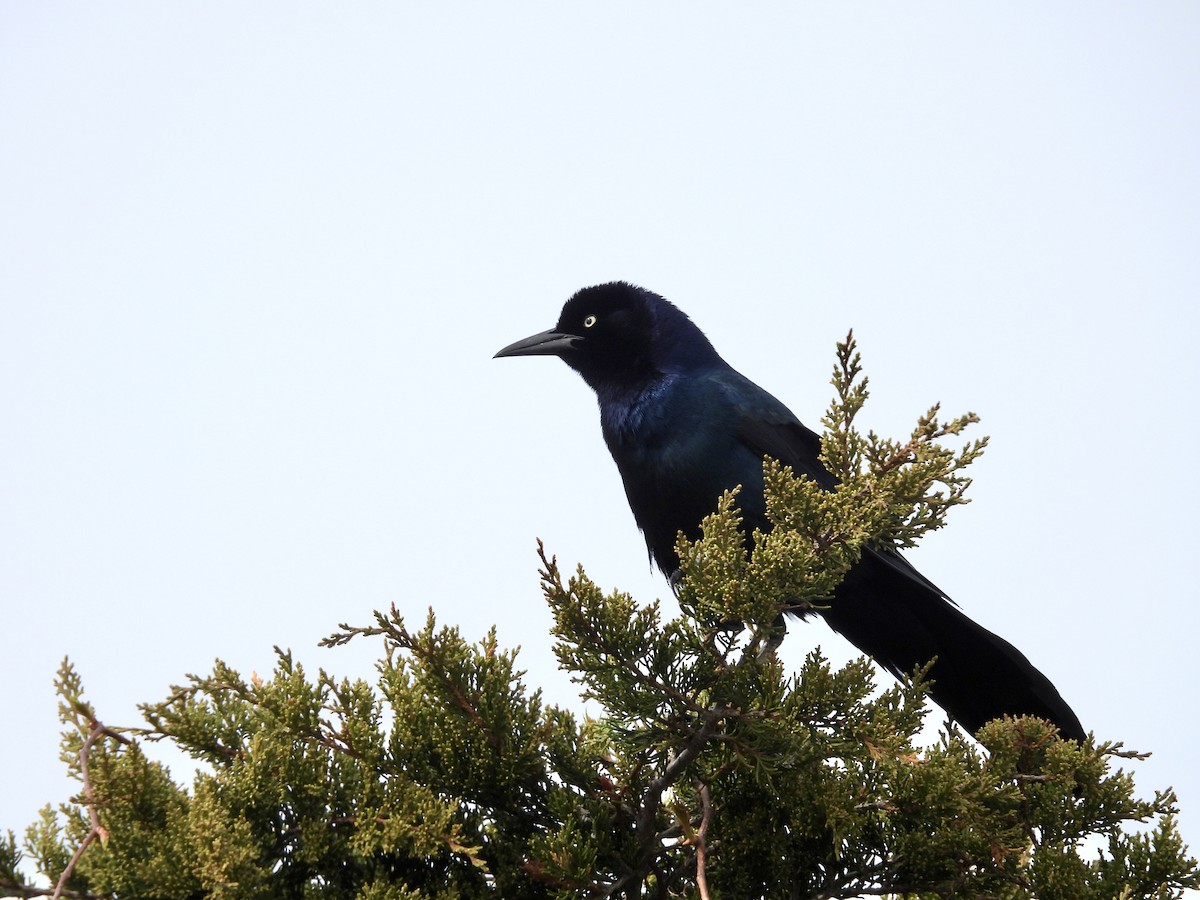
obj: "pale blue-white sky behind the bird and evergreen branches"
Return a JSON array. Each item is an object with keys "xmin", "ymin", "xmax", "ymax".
[{"xmin": 0, "ymin": 2, "xmax": 1200, "ymax": 883}]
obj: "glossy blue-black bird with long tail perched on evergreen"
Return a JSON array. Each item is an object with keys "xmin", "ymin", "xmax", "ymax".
[{"xmin": 496, "ymin": 282, "xmax": 1085, "ymax": 740}]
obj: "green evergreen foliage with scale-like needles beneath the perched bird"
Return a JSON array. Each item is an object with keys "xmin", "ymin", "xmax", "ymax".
[{"xmin": 0, "ymin": 338, "xmax": 1200, "ymax": 900}]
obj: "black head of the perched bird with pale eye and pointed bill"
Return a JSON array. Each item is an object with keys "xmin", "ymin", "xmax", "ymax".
[{"xmin": 496, "ymin": 281, "xmax": 720, "ymax": 391}]
